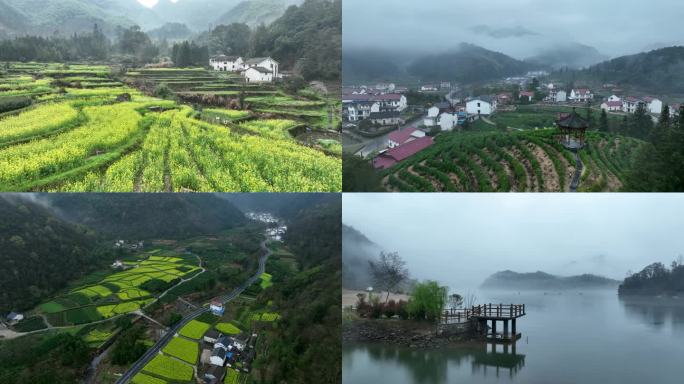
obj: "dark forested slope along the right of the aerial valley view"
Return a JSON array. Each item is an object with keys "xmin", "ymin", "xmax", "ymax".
[{"xmin": 255, "ymin": 195, "xmax": 342, "ymax": 384}]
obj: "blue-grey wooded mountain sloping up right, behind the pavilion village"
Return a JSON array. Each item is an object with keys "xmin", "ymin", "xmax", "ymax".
[{"xmin": 578, "ymin": 46, "xmax": 684, "ymax": 94}]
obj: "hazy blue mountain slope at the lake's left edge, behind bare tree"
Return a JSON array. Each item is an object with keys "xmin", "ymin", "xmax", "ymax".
[{"xmin": 342, "ymin": 224, "xmax": 382, "ymax": 289}]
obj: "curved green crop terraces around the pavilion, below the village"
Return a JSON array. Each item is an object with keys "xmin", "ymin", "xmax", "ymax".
[{"xmin": 383, "ymin": 129, "xmax": 641, "ymax": 192}]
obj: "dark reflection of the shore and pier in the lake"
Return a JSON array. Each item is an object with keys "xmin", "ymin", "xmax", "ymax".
[{"xmin": 343, "ymin": 343, "xmax": 525, "ymax": 383}]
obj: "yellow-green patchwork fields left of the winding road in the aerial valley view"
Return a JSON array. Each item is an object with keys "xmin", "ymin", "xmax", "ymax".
[{"xmin": 37, "ymin": 256, "xmax": 200, "ymax": 326}]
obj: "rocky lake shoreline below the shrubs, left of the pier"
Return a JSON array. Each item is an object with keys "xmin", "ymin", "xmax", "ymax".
[{"xmin": 342, "ymin": 319, "xmax": 481, "ymax": 348}]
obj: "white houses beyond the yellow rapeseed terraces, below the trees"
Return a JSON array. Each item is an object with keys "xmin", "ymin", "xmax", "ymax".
[{"xmin": 209, "ymin": 55, "xmax": 282, "ymax": 83}]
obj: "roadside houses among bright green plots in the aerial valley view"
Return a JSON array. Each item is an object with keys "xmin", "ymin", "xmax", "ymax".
[{"xmin": 200, "ymin": 301, "xmax": 257, "ymax": 384}]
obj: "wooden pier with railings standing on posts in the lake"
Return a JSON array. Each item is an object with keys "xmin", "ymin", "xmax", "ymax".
[{"xmin": 442, "ymin": 304, "xmax": 525, "ymax": 342}]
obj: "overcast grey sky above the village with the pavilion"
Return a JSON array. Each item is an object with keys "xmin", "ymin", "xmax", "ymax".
[{"xmin": 342, "ymin": 0, "xmax": 684, "ymax": 59}]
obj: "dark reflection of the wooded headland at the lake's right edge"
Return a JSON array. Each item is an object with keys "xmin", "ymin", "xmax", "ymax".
[{"xmin": 620, "ymin": 296, "xmax": 684, "ymax": 333}]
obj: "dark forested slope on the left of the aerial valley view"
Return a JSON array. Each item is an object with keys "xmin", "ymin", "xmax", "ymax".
[{"xmin": 0, "ymin": 195, "xmax": 106, "ymax": 314}]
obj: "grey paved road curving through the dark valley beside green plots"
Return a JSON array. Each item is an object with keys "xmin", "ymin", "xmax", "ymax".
[{"xmin": 116, "ymin": 237, "xmax": 273, "ymax": 384}]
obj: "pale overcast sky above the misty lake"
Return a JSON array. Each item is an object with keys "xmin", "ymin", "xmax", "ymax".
[{"xmin": 342, "ymin": 193, "xmax": 684, "ymax": 288}]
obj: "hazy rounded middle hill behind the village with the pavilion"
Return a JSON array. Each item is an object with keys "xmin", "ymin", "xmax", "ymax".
[{"xmin": 408, "ymin": 43, "xmax": 533, "ymax": 84}]
